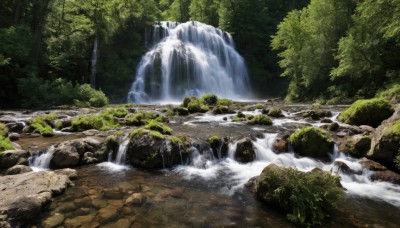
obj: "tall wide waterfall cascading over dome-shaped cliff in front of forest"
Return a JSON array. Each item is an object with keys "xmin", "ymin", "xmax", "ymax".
[{"xmin": 128, "ymin": 21, "xmax": 249, "ymax": 103}]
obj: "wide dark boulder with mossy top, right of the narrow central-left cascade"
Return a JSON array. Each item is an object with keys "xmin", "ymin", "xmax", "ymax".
[{"xmin": 126, "ymin": 130, "xmax": 190, "ymax": 169}]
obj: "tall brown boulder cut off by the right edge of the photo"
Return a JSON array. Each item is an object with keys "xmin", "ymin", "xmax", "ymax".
[{"xmin": 367, "ymin": 106, "xmax": 400, "ymax": 166}]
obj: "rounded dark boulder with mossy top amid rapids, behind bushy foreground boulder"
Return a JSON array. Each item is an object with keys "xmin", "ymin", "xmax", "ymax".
[{"xmin": 289, "ymin": 127, "xmax": 334, "ymax": 159}]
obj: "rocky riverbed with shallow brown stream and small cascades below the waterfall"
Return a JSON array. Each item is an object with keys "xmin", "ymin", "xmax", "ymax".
[{"xmin": 0, "ymin": 101, "xmax": 400, "ymax": 227}]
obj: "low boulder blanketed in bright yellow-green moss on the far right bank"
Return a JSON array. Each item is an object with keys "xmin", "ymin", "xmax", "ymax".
[{"xmin": 339, "ymin": 98, "xmax": 393, "ymax": 127}]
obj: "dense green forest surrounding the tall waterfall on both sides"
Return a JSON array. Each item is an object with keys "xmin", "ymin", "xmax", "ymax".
[{"xmin": 0, "ymin": 0, "xmax": 400, "ymax": 108}]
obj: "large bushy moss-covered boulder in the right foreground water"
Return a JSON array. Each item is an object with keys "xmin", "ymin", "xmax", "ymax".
[{"xmin": 255, "ymin": 164, "xmax": 343, "ymax": 227}]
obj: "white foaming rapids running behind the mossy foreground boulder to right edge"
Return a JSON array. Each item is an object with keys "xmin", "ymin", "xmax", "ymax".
[{"xmin": 175, "ymin": 133, "xmax": 400, "ymax": 207}]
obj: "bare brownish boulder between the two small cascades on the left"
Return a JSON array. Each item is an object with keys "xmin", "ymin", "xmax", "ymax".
[{"xmin": 50, "ymin": 137, "xmax": 103, "ymax": 169}]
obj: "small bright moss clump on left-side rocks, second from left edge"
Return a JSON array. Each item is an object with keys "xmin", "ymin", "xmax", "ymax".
[{"xmin": 28, "ymin": 113, "xmax": 58, "ymax": 137}]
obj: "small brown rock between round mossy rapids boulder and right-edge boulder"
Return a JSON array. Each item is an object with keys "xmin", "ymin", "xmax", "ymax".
[{"xmin": 339, "ymin": 135, "xmax": 371, "ymax": 158}]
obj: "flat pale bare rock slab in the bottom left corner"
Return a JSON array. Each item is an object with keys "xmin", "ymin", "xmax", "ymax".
[{"xmin": 0, "ymin": 171, "xmax": 71, "ymax": 227}]
